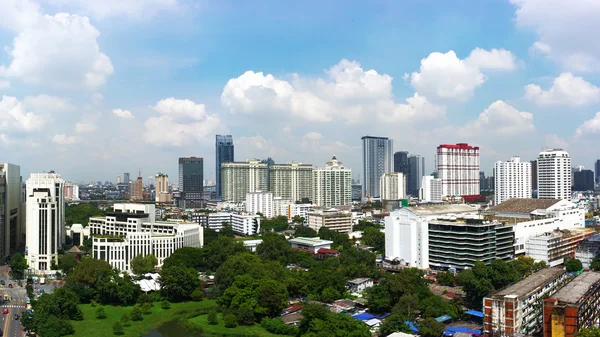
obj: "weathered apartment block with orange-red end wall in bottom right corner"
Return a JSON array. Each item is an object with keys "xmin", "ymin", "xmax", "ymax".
[{"xmin": 544, "ymin": 272, "xmax": 600, "ymax": 337}]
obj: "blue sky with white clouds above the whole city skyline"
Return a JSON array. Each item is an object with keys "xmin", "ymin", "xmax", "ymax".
[{"xmin": 0, "ymin": 0, "xmax": 600, "ymax": 181}]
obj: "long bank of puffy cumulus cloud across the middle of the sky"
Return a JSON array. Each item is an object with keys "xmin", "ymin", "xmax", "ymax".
[{"xmin": 221, "ymin": 59, "xmax": 440, "ymax": 124}]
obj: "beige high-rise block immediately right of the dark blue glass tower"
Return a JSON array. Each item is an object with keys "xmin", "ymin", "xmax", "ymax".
[{"xmin": 221, "ymin": 160, "xmax": 268, "ymax": 202}]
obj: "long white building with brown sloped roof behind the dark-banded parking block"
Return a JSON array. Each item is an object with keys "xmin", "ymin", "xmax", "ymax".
[{"xmin": 487, "ymin": 198, "xmax": 585, "ymax": 255}]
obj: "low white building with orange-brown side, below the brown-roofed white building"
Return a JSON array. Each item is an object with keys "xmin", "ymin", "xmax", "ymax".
[{"xmin": 525, "ymin": 228, "xmax": 595, "ymax": 267}]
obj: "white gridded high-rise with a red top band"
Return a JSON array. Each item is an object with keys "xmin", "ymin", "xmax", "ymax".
[{"xmin": 437, "ymin": 143, "xmax": 480, "ymax": 196}]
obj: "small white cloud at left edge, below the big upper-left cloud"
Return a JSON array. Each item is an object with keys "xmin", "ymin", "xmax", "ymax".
[{"xmin": 0, "ymin": 96, "xmax": 47, "ymax": 132}]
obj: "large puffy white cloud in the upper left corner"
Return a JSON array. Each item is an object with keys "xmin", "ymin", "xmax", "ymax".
[{"xmin": 0, "ymin": 0, "xmax": 113, "ymax": 89}]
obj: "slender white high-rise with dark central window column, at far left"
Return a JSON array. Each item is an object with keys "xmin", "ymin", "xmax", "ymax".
[{"xmin": 25, "ymin": 171, "xmax": 65, "ymax": 272}]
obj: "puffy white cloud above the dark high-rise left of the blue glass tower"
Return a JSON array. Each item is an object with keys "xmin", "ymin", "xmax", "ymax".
[{"xmin": 144, "ymin": 98, "xmax": 224, "ymax": 146}]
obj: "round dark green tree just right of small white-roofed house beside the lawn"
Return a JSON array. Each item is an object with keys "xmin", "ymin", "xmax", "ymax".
[{"xmin": 160, "ymin": 265, "xmax": 200, "ymax": 302}]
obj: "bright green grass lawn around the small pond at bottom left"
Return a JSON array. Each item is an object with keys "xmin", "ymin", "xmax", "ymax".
[{"xmin": 71, "ymin": 300, "xmax": 215, "ymax": 337}]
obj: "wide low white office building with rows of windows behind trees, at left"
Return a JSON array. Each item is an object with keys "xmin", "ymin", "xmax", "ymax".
[{"xmin": 88, "ymin": 204, "xmax": 204, "ymax": 271}]
